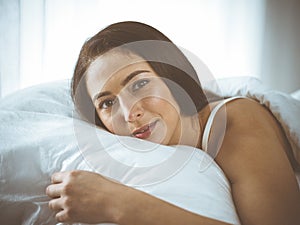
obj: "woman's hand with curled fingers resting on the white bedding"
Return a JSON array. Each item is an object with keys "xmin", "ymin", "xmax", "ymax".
[{"xmin": 46, "ymin": 170, "xmax": 122, "ymax": 223}]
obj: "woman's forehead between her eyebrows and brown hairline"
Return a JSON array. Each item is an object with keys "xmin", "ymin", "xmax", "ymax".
[{"xmin": 85, "ymin": 51, "xmax": 152, "ymax": 95}]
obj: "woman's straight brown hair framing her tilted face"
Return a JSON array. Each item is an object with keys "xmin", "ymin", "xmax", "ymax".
[{"xmin": 71, "ymin": 21, "xmax": 208, "ymax": 128}]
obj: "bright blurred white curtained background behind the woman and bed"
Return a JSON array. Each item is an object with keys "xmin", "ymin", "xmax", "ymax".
[{"xmin": 0, "ymin": 0, "xmax": 300, "ymax": 97}]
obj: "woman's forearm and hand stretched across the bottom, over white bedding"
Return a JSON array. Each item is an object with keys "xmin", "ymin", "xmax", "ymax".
[{"xmin": 46, "ymin": 171, "xmax": 232, "ymax": 225}]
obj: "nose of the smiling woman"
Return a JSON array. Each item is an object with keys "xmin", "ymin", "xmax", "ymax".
[{"xmin": 119, "ymin": 97, "xmax": 144, "ymax": 122}]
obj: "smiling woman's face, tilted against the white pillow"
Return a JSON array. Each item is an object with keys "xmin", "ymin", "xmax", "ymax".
[{"xmin": 86, "ymin": 52, "xmax": 181, "ymax": 145}]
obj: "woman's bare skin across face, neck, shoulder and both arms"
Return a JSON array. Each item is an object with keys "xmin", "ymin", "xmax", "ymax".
[{"xmin": 46, "ymin": 51, "xmax": 300, "ymax": 225}]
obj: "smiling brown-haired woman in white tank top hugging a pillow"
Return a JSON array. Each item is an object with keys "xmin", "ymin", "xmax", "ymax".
[{"xmin": 46, "ymin": 22, "xmax": 300, "ymax": 225}]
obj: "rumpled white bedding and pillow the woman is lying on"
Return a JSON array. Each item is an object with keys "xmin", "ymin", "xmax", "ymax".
[{"xmin": 0, "ymin": 77, "xmax": 300, "ymax": 225}]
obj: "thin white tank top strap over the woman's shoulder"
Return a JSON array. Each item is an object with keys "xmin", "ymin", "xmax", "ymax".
[{"xmin": 202, "ymin": 96, "xmax": 247, "ymax": 152}]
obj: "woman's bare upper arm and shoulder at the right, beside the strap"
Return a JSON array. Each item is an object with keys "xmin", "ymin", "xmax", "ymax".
[{"xmin": 216, "ymin": 100, "xmax": 300, "ymax": 225}]
